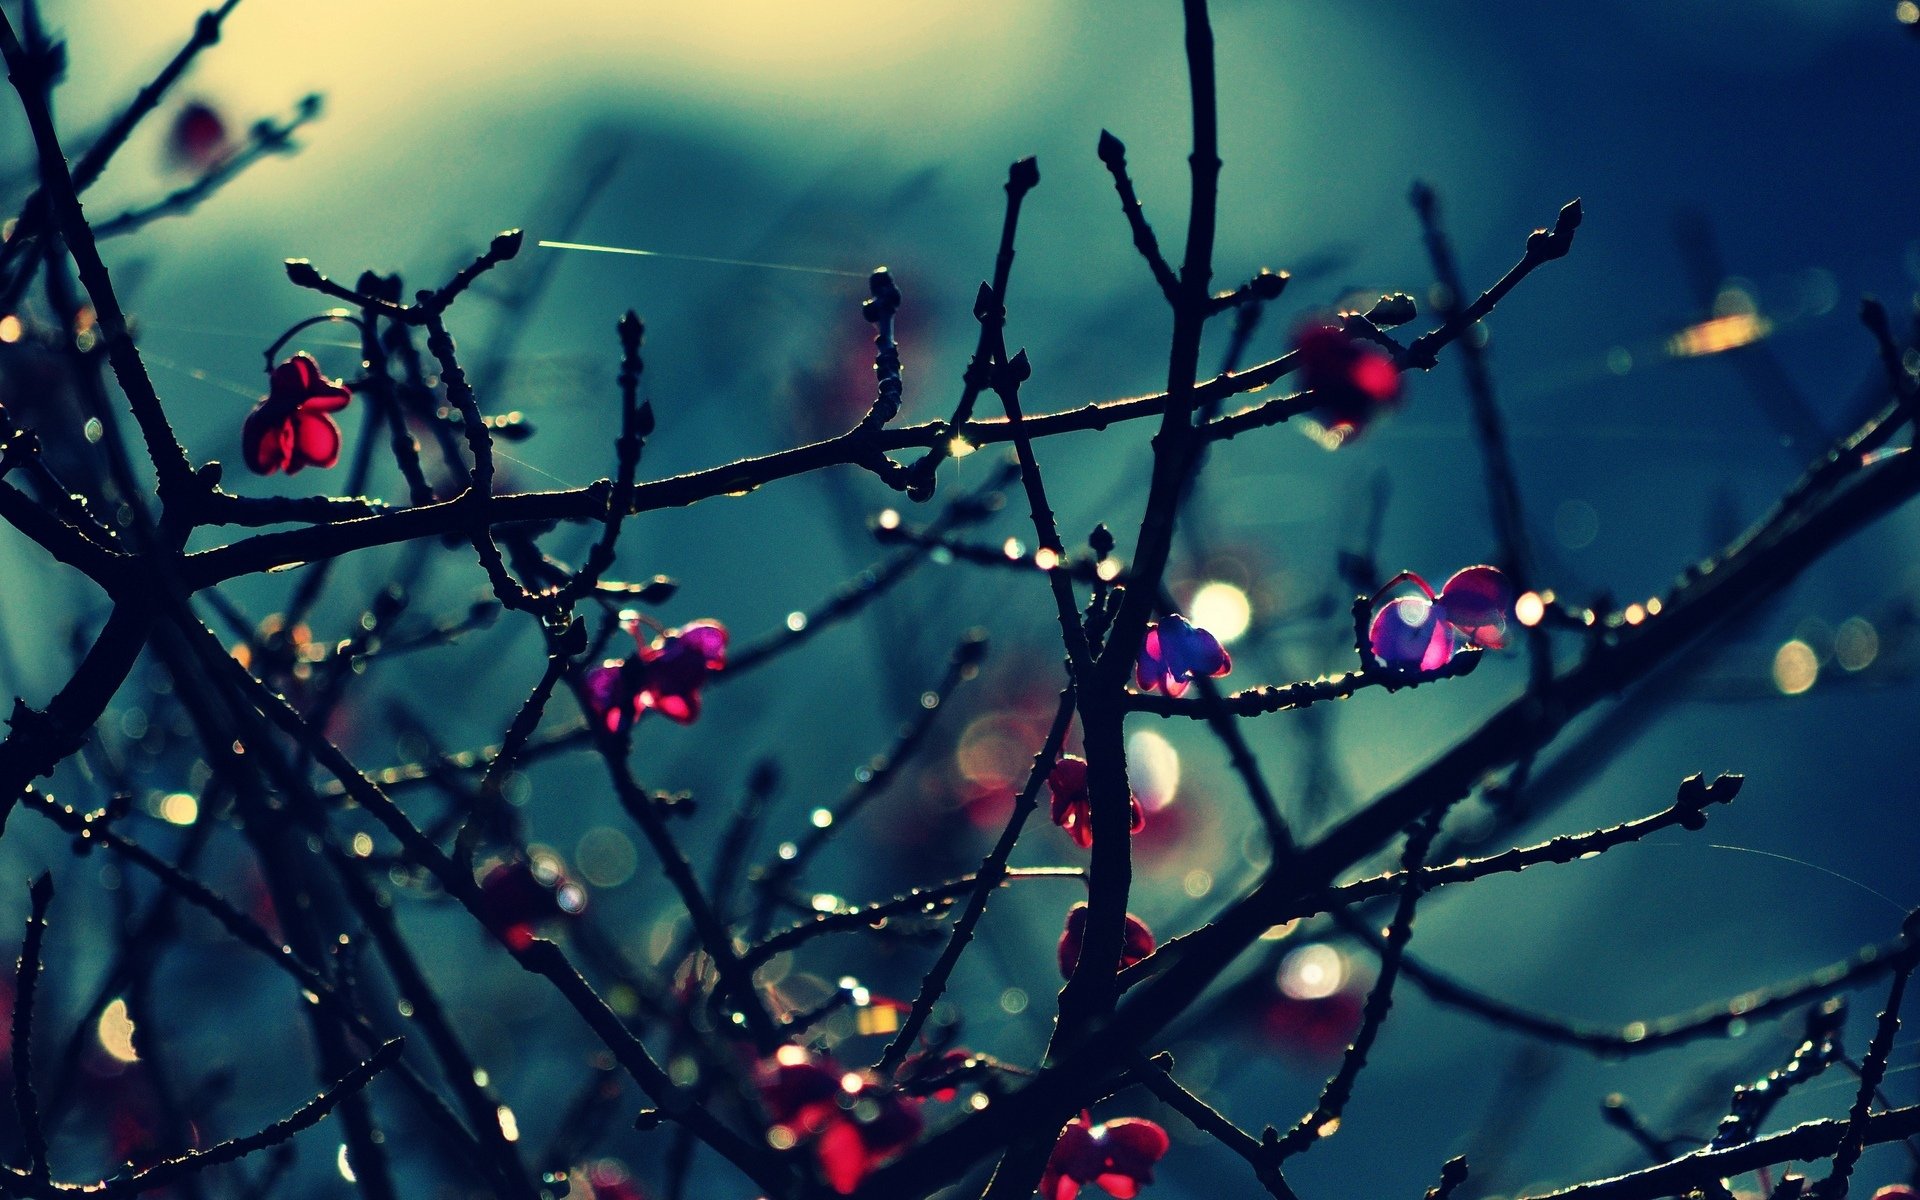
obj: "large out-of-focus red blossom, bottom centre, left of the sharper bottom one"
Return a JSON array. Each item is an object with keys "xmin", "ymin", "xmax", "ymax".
[{"xmin": 755, "ymin": 1046, "xmax": 920, "ymax": 1196}]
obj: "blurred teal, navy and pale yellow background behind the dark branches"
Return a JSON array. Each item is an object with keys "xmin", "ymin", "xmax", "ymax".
[{"xmin": 0, "ymin": 0, "xmax": 1920, "ymax": 1200}]
